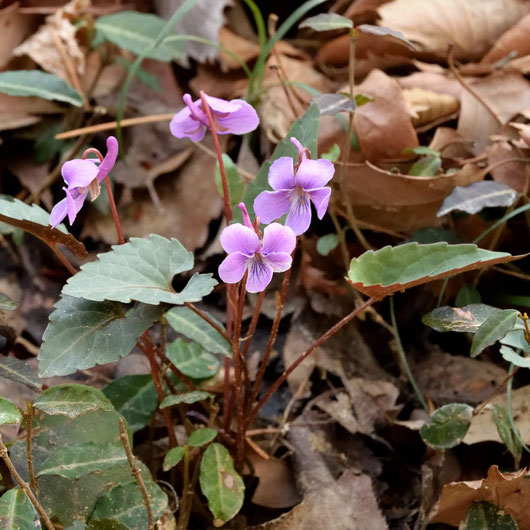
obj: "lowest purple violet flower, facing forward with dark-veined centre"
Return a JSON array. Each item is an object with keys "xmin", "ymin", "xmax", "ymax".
[{"xmin": 219, "ymin": 203, "xmax": 296, "ymax": 293}]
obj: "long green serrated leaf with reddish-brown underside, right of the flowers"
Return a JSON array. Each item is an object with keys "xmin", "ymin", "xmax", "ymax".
[{"xmin": 348, "ymin": 242, "xmax": 523, "ymax": 298}]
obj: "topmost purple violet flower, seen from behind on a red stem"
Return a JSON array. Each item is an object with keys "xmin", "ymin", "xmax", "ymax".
[{"xmin": 169, "ymin": 92, "xmax": 259, "ymax": 142}]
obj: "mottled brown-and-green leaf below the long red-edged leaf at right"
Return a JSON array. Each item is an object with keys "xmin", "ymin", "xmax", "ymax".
[{"xmin": 421, "ymin": 304, "xmax": 501, "ymax": 333}]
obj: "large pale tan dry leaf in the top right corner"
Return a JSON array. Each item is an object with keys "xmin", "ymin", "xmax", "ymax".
[{"xmin": 378, "ymin": 0, "xmax": 530, "ymax": 60}]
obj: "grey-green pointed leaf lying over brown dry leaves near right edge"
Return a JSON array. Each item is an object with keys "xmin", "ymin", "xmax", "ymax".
[{"xmin": 436, "ymin": 180, "xmax": 518, "ymax": 217}]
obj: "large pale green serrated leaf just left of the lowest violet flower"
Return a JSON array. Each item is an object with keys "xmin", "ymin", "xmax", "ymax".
[{"xmin": 62, "ymin": 234, "xmax": 217, "ymax": 305}]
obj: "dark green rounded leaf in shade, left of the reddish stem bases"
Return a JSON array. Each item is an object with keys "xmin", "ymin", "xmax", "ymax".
[{"xmin": 102, "ymin": 375, "xmax": 158, "ymax": 432}]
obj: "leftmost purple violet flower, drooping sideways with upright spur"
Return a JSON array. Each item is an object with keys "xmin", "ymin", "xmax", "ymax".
[{"xmin": 50, "ymin": 136, "xmax": 119, "ymax": 228}]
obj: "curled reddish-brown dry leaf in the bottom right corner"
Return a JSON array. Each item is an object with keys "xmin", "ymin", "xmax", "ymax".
[{"xmin": 431, "ymin": 466, "xmax": 530, "ymax": 530}]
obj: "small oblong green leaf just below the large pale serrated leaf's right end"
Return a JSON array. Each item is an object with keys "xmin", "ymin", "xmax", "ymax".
[{"xmin": 166, "ymin": 307, "xmax": 232, "ymax": 357}]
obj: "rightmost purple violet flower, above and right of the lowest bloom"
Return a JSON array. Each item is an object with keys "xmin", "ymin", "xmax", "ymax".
[{"xmin": 254, "ymin": 138, "xmax": 335, "ymax": 236}]
